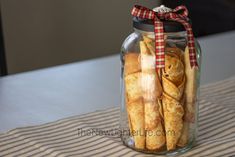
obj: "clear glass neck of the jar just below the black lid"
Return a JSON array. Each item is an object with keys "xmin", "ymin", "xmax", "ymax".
[{"xmin": 134, "ymin": 28, "xmax": 187, "ymax": 39}]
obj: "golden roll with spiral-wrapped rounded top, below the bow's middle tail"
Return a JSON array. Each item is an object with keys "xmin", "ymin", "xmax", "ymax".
[{"xmin": 162, "ymin": 54, "xmax": 185, "ymax": 150}]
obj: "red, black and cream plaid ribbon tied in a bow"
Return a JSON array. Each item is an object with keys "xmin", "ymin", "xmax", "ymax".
[{"xmin": 131, "ymin": 5, "xmax": 198, "ymax": 69}]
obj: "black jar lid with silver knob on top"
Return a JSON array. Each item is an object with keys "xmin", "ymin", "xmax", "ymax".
[{"xmin": 133, "ymin": 5, "xmax": 190, "ymax": 32}]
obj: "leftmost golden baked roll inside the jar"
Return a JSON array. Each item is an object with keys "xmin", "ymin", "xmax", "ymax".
[{"xmin": 124, "ymin": 53, "xmax": 145, "ymax": 149}]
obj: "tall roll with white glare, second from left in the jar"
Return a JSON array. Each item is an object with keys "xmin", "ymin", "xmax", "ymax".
[{"xmin": 140, "ymin": 37, "xmax": 165, "ymax": 150}]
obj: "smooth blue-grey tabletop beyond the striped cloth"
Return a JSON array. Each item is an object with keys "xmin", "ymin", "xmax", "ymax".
[{"xmin": 0, "ymin": 31, "xmax": 235, "ymax": 132}]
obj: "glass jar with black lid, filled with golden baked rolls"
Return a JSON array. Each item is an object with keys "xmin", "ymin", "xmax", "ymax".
[{"xmin": 120, "ymin": 9, "xmax": 201, "ymax": 155}]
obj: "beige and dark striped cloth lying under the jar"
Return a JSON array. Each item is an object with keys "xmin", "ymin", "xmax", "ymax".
[{"xmin": 0, "ymin": 77, "xmax": 235, "ymax": 157}]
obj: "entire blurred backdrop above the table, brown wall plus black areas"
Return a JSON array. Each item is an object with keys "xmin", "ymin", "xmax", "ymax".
[{"xmin": 0, "ymin": 0, "xmax": 235, "ymax": 75}]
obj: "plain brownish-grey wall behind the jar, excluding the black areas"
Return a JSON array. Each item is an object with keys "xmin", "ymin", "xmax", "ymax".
[{"xmin": 1, "ymin": 0, "xmax": 158, "ymax": 74}]
